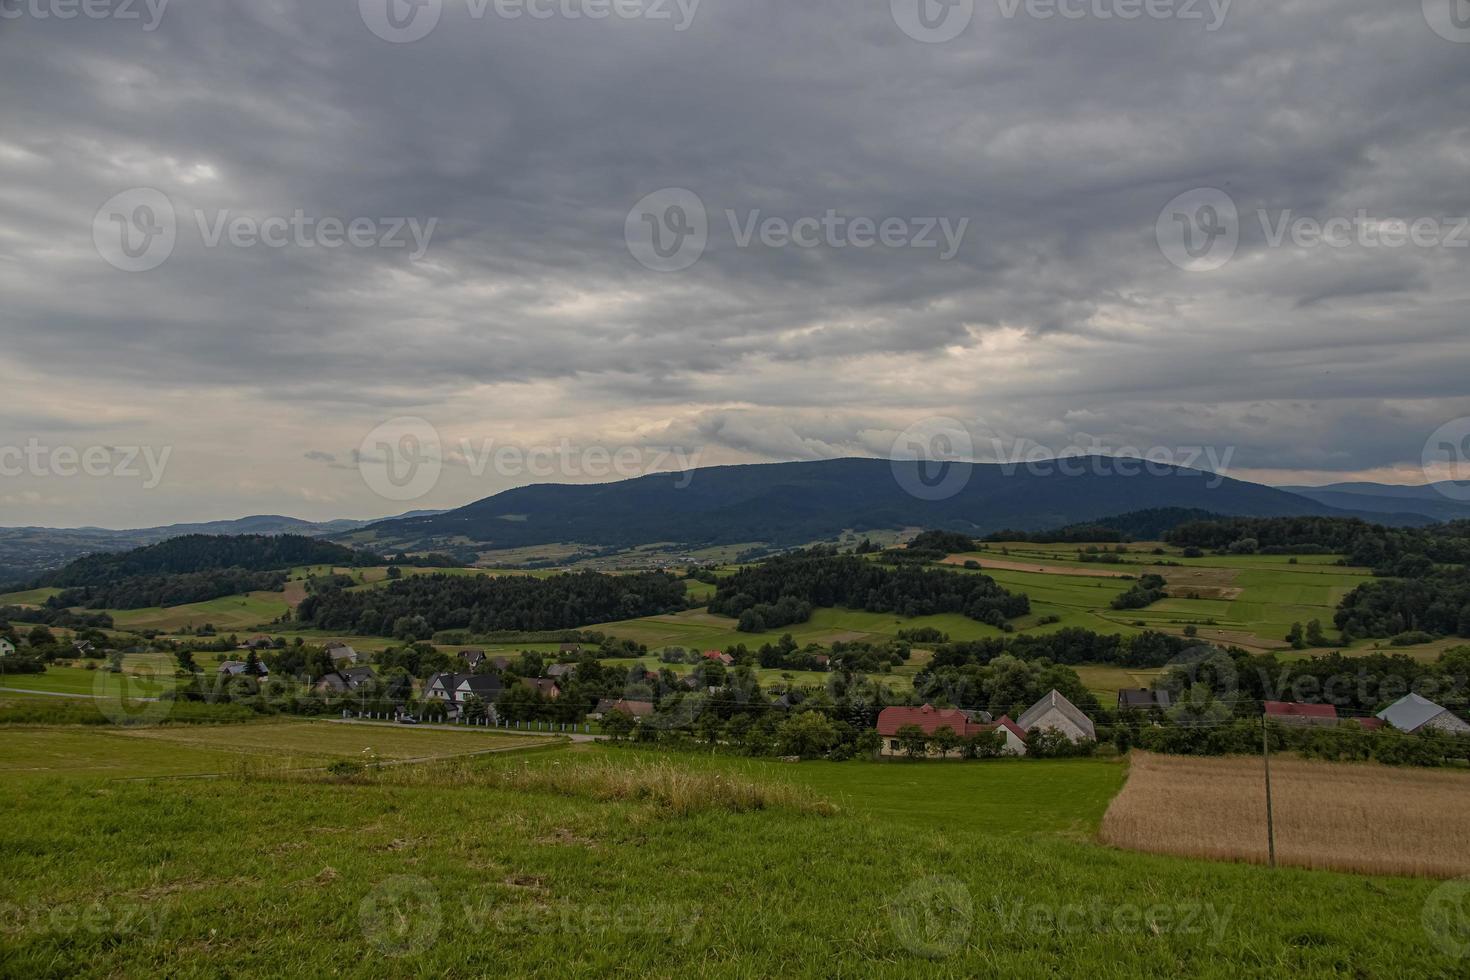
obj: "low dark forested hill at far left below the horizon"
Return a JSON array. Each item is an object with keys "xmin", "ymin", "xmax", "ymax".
[{"xmin": 38, "ymin": 535, "xmax": 382, "ymax": 589}]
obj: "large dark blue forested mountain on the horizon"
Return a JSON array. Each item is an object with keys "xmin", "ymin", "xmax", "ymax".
[{"xmin": 358, "ymin": 458, "xmax": 1422, "ymax": 550}]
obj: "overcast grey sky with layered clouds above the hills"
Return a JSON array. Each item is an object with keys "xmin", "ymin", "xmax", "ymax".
[{"xmin": 0, "ymin": 0, "xmax": 1470, "ymax": 526}]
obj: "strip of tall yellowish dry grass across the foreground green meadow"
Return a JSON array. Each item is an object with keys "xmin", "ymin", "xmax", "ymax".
[{"xmin": 282, "ymin": 758, "xmax": 836, "ymax": 815}]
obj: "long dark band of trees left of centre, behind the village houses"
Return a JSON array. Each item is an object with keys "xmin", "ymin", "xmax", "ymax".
[{"xmin": 297, "ymin": 572, "xmax": 686, "ymax": 641}]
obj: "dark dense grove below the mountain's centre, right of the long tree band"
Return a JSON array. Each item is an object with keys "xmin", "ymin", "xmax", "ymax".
[{"xmin": 710, "ymin": 550, "xmax": 1030, "ymax": 629}]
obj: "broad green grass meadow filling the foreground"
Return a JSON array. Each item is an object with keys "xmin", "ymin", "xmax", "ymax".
[{"xmin": 0, "ymin": 732, "xmax": 1464, "ymax": 979}]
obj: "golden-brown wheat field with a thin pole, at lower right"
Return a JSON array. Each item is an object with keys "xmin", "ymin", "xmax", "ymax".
[{"xmin": 1101, "ymin": 752, "xmax": 1470, "ymax": 877}]
